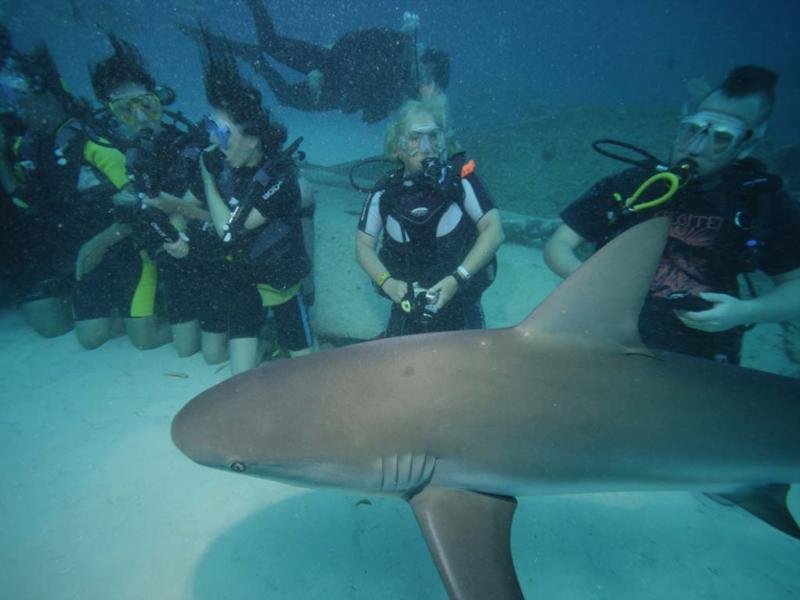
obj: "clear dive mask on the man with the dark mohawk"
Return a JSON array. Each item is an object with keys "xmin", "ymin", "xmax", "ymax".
[{"xmin": 676, "ymin": 111, "xmax": 766, "ymax": 160}]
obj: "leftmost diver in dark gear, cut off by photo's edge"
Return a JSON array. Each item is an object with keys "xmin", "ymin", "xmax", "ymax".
[{"xmin": 0, "ymin": 27, "xmax": 76, "ymax": 337}]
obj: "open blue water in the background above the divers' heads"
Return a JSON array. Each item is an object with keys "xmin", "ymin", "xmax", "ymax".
[{"xmin": 5, "ymin": 0, "xmax": 800, "ymax": 163}]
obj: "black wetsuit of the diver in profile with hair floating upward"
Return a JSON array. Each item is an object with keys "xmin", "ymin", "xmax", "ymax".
[{"xmin": 195, "ymin": 147, "xmax": 314, "ymax": 351}]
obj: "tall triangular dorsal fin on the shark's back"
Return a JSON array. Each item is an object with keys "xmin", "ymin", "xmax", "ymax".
[{"xmin": 517, "ymin": 217, "xmax": 669, "ymax": 354}]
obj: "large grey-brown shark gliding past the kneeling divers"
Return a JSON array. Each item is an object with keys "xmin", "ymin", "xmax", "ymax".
[{"xmin": 172, "ymin": 219, "xmax": 800, "ymax": 599}]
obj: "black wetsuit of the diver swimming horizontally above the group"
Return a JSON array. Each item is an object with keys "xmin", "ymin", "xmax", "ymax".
[{"xmin": 244, "ymin": 0, "xmax": 417, "ymax": 123}]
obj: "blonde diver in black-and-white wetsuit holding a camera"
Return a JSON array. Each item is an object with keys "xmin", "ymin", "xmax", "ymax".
[{"xmin": 356, "ymin": 97, "xmax": 505, "ymax": 337}]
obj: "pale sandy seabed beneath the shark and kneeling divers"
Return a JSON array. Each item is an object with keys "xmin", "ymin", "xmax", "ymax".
[{"xmin": 0, "ymin": 180, "xmax": 800, "ymax": 600}]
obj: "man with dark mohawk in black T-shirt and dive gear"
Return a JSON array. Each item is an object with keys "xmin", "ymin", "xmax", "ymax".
[{"xmin": 545, "ymin": 65, "xmax": 800, "ymax": 364}]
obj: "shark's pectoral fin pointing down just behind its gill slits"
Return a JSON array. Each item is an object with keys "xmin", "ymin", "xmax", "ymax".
[{"xmin": 409, "ymin": 487, "xmax": 523, "ymax": 600}]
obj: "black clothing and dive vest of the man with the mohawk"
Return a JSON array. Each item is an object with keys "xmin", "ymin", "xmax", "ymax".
[{"xmin": 561, "ymin": 161, "xmax": 800, "ymax": 363}]
